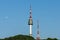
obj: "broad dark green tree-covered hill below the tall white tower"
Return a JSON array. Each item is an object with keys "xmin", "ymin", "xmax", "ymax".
[{"xmin": 0, "ymin": 35, "xmax": 34, "ymax": 40}]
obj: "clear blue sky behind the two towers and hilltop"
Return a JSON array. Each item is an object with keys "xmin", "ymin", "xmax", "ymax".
[{"xmin": 0, "ymin": 0, "xmax": 60, "ymax": 38}]
